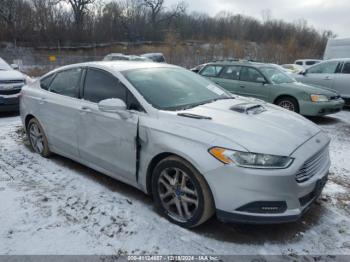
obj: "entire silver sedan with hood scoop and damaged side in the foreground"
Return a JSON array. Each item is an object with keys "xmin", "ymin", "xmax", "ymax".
[{"xmin": 20, "ymin": 62, "xmax": 330, "ymax": 227}]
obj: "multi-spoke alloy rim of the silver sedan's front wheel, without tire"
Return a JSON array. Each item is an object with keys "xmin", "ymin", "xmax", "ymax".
[{"xmin": 158, "ymin": 168, "xmax": 199, "ymax": 222}]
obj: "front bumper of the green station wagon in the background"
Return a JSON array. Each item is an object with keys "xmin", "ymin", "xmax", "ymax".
[{"xmin": 300, "ymin": 99, "xmax": 345, "ymax": 116}]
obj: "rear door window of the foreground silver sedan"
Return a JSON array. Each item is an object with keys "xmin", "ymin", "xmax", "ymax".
[{"xmin": 50, "ymin": 68, "xmax": 82, "ymax": 98}]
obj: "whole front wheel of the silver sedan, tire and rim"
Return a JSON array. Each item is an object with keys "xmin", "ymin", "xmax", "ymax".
[{"xmin": 152, "ymin": 156, "xmax": 215, "ymax": 228}]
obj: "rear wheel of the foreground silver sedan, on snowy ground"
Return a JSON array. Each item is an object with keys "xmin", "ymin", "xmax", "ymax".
[{"xmin": 27, "ymin": 118, "xmax": 51, "ymax": 157}]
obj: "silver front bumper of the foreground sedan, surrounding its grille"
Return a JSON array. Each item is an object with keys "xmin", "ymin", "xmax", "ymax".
[{"xmin": 204, "ymin": 132, "xmax": 330, "ymax": 224}]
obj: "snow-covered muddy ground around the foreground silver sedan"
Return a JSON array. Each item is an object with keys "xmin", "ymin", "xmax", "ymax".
[{"xmin": 0, "ymin": 111, "xmax": 350, "ymax": 258}]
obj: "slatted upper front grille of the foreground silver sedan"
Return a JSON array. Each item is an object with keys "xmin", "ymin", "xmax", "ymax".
[{"xmin": 295, "ymin": 146, "xmax": 329, "ymax": 183}]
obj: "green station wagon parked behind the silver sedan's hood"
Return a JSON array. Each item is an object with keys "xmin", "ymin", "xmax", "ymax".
[{"xmin": 199, "ymin": 62, "xmax": 344, "ymax": 116}]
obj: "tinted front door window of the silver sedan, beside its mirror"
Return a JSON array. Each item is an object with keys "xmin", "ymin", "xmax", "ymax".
[{"xmin": 84, "ymin": 69, "xmax": 126, "ymax": 103}]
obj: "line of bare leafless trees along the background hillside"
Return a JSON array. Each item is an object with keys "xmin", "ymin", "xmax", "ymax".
[{"xmin": 0, "ymin": 0, "xmax": 334, "ymax": 60}]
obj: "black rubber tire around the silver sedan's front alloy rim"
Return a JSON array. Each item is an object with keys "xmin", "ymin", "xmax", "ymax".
[{"xmin": 152, "ymin": 156, "xmax": 215, "ymax": 228}]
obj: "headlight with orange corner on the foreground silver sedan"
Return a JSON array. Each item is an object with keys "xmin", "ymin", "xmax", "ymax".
[{"xmin": 209, "ymin": 147, "xmax": 293, "ymax": 169}]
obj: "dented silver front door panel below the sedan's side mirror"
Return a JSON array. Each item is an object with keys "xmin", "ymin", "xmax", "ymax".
[{"xmin": 78, "ymin": 102, "xmax": 138, "ymax": 181}]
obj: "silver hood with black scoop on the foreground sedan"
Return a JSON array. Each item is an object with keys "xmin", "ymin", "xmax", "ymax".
[{"xmin": 172, "ymin": 98, "xmax": 321, "ymax": 156}]
